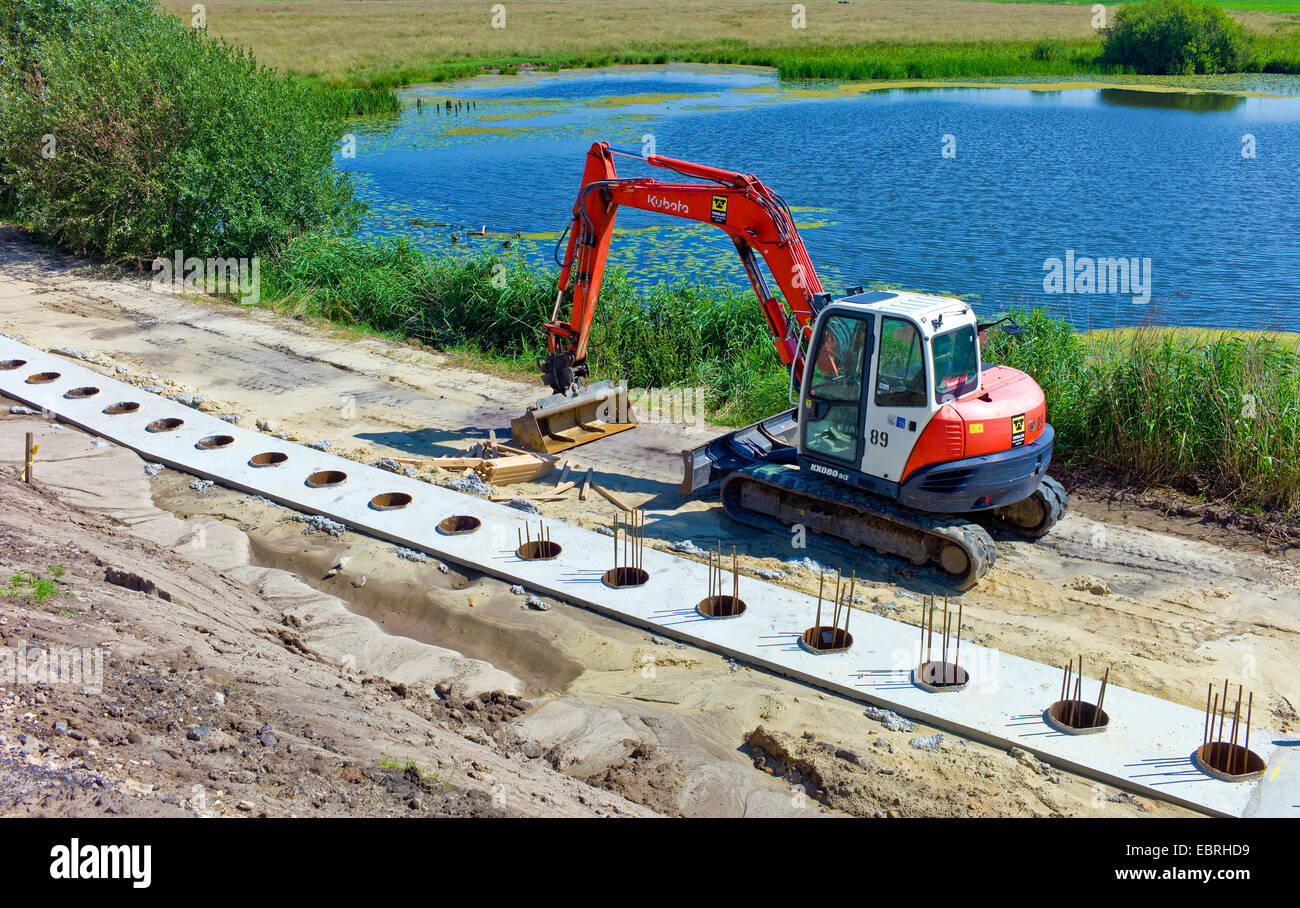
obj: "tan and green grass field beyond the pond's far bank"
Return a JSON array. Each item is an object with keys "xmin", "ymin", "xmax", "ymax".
[{"xmin": 165, "ymin": 0, "xmax": 1300, "ymax": 86}]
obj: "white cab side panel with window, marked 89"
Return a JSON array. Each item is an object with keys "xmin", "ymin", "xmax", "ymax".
[{"xmin": 863, "ymin": 315, "xmax": 933, "ymax": 484}]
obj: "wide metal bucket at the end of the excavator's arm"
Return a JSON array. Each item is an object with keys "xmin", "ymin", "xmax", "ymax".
[{"xmin": 510, "ymin": 381, "xmax": 637, "ymax": 454}]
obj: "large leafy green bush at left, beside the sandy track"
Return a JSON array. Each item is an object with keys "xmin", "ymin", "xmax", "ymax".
[{"xmin": 0, "ymin": 0, "xmax": 361, "ymax": 260}]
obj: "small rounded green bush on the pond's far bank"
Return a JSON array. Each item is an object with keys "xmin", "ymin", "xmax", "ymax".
[{"xmin": 1102, "ymin": 0, "xmax": 1252, "ymax": 75}]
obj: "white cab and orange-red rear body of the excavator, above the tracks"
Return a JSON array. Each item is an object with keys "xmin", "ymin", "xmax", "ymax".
[{"xmin": 797, "ymin": 291, "xmax": 1052, "ymax": 513}]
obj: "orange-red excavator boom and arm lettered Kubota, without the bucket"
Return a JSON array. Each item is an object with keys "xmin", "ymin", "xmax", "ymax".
[{"xmin": 542, "ymin": 142, "xmax": 822, "ymax": 394}]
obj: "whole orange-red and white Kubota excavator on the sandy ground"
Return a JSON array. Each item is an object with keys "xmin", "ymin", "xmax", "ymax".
[{"xmin": 511, "ymin": 142, "xmax": 1067, "ymax": 589}]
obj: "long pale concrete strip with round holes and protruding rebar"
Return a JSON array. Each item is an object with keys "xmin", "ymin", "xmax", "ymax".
[{"xmin": 0, "ymin": 337, "xmax": 1300, "ymax": 817}]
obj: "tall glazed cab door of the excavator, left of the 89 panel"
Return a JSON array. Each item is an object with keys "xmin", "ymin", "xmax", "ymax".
[{"xmin": 800, "ymin": 310, "xmax": 874, "ymax": 470}]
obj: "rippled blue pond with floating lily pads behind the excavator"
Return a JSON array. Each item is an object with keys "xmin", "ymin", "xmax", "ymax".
[{"xmin": 338, "ymin": 65, "xmax": 1300, "ymax": 330}]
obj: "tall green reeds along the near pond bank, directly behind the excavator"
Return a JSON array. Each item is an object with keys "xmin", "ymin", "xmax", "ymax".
[{"xmin": 263, "ymin": 237, "xmax": 1300, "ymax": 519}]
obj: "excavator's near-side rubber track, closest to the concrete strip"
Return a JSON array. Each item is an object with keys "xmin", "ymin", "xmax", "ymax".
[{"xmin": 722, "ymin": 463, "xmax": 997, "ymax": 591}]
